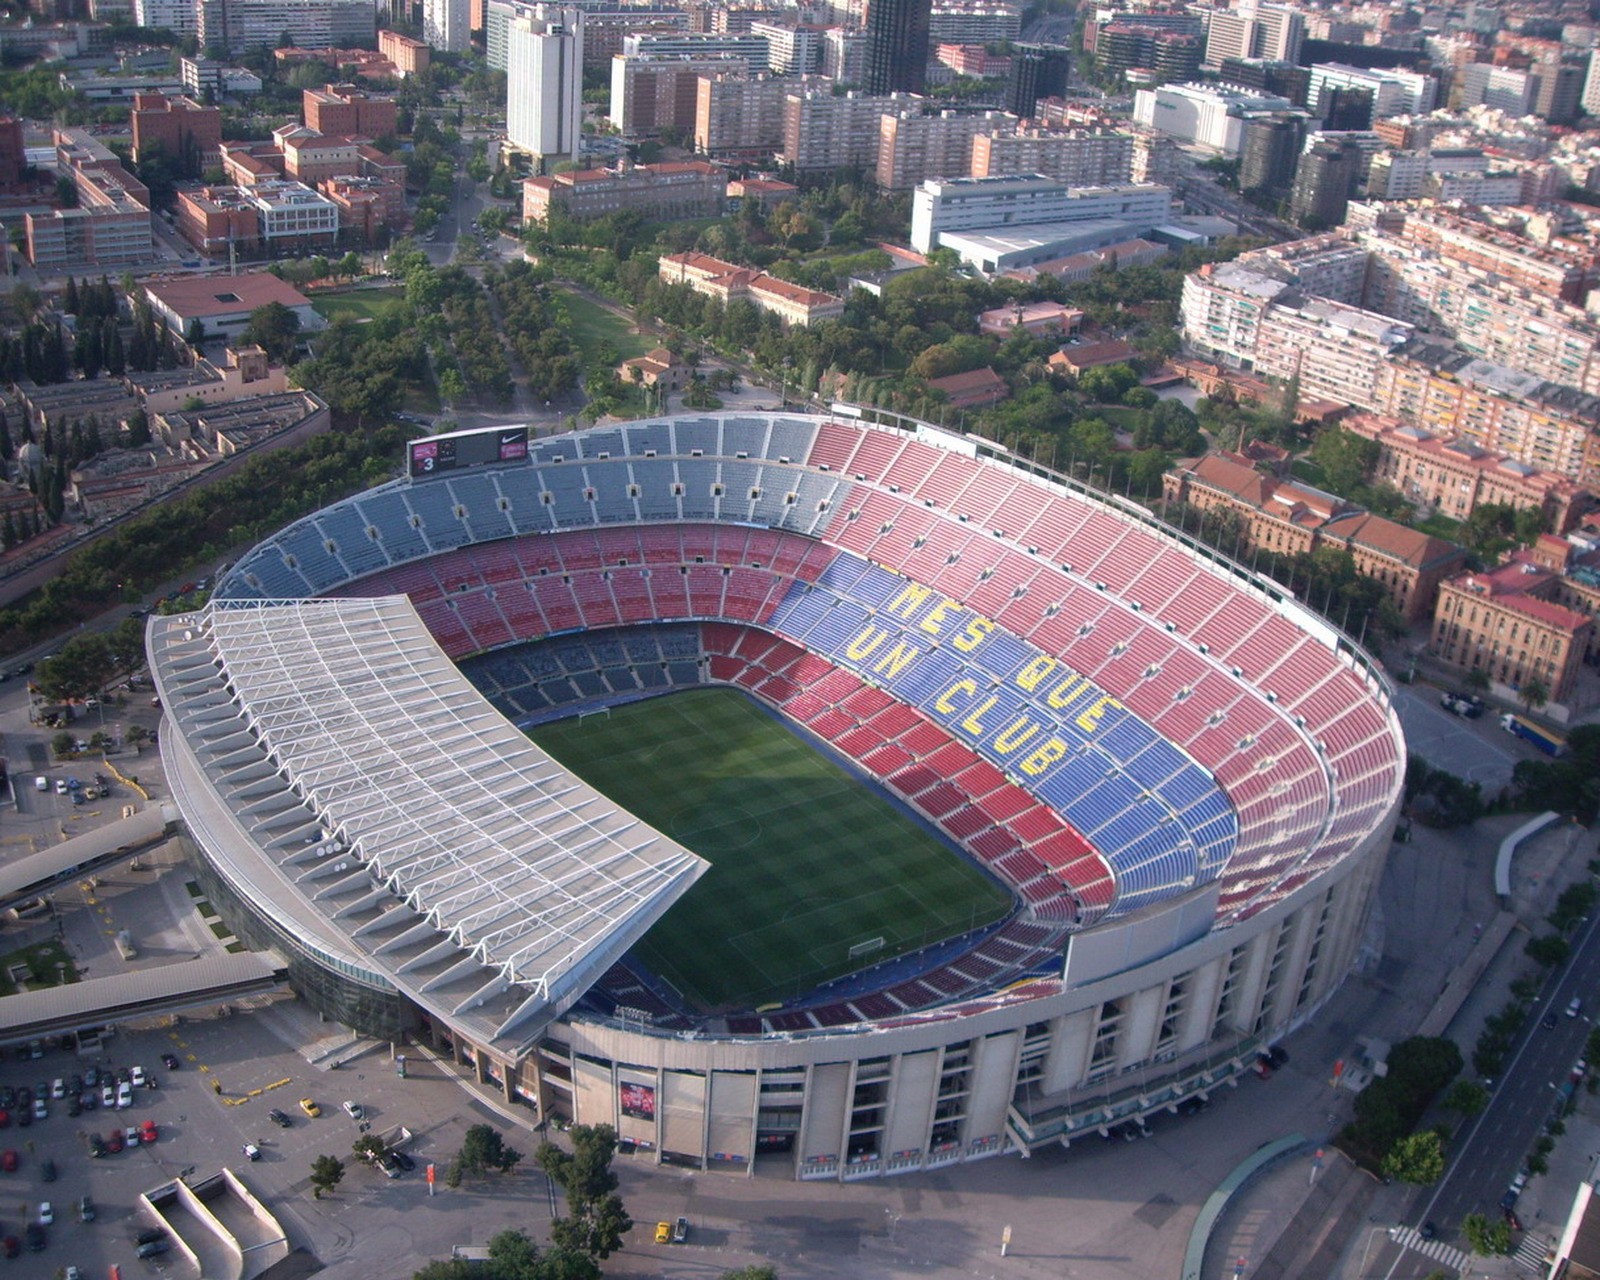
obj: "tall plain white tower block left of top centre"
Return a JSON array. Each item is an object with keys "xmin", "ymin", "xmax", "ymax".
[{"xmin": 506, "ymin": 5, "xmax": 584, "ymax": 171}]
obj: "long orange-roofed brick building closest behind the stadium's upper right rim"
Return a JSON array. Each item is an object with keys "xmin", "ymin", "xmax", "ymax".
[{"xmin": 1162, "ymin": 453, "xmax": 1466, "ymax": 622}]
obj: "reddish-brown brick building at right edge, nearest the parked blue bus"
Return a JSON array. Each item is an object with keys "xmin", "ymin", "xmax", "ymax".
[{"xmin": 1429, "ymin": 553, "xmax": 1595, "ymax": 702}]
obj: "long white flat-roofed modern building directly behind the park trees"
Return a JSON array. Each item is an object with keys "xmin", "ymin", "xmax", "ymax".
[{"xmin": 910, "ymin": 173, "xmax": 1173, "ymax": 253}]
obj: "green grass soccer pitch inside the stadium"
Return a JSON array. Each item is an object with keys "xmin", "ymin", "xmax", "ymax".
[{"xmin": 530, "ymin": 688, "xmax": 1011, "ymax": 1011}]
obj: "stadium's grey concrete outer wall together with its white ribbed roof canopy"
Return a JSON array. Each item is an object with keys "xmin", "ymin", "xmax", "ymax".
[{"xmin": 149, "ymin": 414, "xmax": 1403, "ymax": 1179}]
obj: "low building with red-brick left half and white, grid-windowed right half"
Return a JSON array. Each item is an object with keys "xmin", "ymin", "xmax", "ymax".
[{"xmin": 176, "ymin": 179, "xmax": 339, "ymax": 258}]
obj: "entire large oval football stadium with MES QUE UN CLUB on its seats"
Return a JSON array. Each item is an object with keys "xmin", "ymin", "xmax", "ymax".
[{"xmin": 149, "ymin": 405, "xmax": 1405, "ymax": 1179}]
